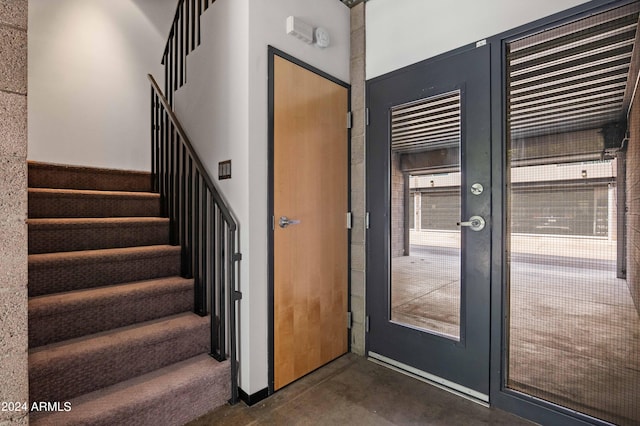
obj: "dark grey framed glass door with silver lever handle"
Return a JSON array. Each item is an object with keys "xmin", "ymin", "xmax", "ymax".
[{"xmin": 367, "ymin": 43, "xmax": 491, "ymax": 401}]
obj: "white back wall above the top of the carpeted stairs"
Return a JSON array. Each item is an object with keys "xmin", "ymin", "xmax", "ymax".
[{"xmin": 28, "ymin": 0, "xmax": 177, "ymax": 170}]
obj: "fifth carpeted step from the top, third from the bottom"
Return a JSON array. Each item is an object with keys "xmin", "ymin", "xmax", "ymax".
[{"xmin": 29, "ymin": 277, "xmax": 193, "ymax": 348}]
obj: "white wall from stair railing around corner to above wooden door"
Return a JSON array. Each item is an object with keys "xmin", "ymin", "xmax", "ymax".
[{"xmin": 175, "ymin": 0, "xmax": 350, "ymax": 394}]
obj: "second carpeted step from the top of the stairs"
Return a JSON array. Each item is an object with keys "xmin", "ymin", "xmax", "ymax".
[{"xmin": 28, "ymin": 188, "xmax": 160, "ymax": 218}]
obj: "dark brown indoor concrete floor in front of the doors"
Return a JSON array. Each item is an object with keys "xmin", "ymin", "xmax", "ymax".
[{"xmin": 188, "ymin": 354, "xmax": 532, "ymax": 426}]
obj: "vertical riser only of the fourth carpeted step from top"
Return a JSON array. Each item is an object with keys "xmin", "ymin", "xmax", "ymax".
[{"xmin": 29, "ymin": 252, "xmax": 180, "ymax": 297}]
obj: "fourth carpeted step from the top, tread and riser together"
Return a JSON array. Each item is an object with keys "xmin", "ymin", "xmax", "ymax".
[{"xmin": 29, "ymin": 245, "xmax": 181, "ymax": 297}]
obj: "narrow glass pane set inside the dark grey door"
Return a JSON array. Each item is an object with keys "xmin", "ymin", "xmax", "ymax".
[{"xmin": 390, "ymin": 91, "xmax": 461, "ymax": 340}]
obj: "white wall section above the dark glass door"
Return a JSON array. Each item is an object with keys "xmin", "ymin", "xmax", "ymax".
[{"xmin": 366, "ymin": 0, "xmax": 587, "ymax": 79}]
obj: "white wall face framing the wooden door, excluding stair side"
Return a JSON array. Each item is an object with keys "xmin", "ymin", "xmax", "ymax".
[{"xmin": 248, "ymin": 0, "xmax": 350, "ymax": 392}]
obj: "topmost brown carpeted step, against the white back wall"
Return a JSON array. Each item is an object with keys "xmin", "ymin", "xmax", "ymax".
[{"xmin": 28, "ymin": 161, "xmax": 151, "ymax": 192}]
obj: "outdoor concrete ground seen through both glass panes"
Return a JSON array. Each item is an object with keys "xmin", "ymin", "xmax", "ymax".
[{"xmin": 392, "ymin": 235, "xmax": 640, "ymax": 425}]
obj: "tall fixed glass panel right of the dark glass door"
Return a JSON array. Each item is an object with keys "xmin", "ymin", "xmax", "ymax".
[{"xmin": 505, "ymin": 2, "xmax": 640, "ymax": 425}]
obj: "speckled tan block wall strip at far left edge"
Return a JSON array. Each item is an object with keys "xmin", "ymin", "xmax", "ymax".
[{"xmin": 0, "ymin": 0, "xmax": 29, "ymax": 426}]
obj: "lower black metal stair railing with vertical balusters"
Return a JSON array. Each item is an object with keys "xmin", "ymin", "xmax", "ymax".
[{"xmin": 148, "ymin": 74, "xmax": 242, "ymax": 404}]
